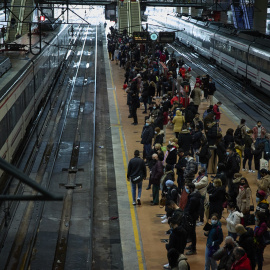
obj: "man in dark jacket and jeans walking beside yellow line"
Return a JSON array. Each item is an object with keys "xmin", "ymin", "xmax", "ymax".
[{"xmin": 127, "ymin": 150, "xmax": 146, "ymax": 205}]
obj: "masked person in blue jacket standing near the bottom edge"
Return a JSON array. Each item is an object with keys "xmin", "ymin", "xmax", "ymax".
[{"xmin": 204, "ymin": 213, "xmax": 223, "ymax": 270}]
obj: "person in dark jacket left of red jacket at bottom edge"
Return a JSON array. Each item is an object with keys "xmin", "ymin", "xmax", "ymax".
[{"xmin": 213, "ymin": 236, "xmax": 238, "ymax": 270}]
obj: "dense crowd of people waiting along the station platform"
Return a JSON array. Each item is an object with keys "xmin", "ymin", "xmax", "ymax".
[{"xmin": 107, "ymin": 25, "xmax": 270, "ymax": 270}]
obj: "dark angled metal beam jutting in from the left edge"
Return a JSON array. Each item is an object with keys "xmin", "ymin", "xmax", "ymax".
[{"xmin": 0, "ymin": 158, "xmax": 63, "ymax": 201}]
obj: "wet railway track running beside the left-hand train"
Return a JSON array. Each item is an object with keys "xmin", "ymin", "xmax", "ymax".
[{"xmin": 0, "ymin": 26, "xmax": 97, "ymax": 269}]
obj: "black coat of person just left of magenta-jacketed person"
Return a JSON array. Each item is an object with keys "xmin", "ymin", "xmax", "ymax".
[{"xmin": 238, "ymin": 227, "xmax": 256, "ymax": 269}]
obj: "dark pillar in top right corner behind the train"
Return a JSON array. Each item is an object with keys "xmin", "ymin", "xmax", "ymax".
[{"xmin": 253, "ymin": 0, "xmax": 268, "ymax": 34}]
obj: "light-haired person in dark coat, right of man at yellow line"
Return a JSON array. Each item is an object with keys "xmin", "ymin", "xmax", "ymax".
[{"xmin": 150, "ymin": 154, "xmax": 163, "ymax": 205}]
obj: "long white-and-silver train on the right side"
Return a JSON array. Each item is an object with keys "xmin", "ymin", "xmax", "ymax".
[{"xmin": 148, "ymin": 12, "xmax": 270, "ymax": 95}]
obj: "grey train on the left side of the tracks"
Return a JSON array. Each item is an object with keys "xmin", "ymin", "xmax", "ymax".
[{"xmin": 0, "ymin": 25, "xmax": 70, "ymax": 166}]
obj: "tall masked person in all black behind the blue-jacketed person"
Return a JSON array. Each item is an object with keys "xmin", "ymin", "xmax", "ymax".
[{"xmin": 184, "ymin": 183, "xmax": 201, "ymax": 255}]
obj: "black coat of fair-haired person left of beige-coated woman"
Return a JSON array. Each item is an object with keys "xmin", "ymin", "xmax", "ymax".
[{"xmin": 207, "ymin": 183, "xmax": 226, "ymax": 218}]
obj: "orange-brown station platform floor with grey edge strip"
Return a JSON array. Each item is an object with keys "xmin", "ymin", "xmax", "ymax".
[{"xmin": 103, "ymin": 45, "xmax": 270, "ymax": 270}]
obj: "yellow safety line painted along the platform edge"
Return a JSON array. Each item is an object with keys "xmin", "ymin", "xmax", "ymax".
[{"xmin": 109, "ymin": 51, "xmax": 144, "ymax": 270}]
